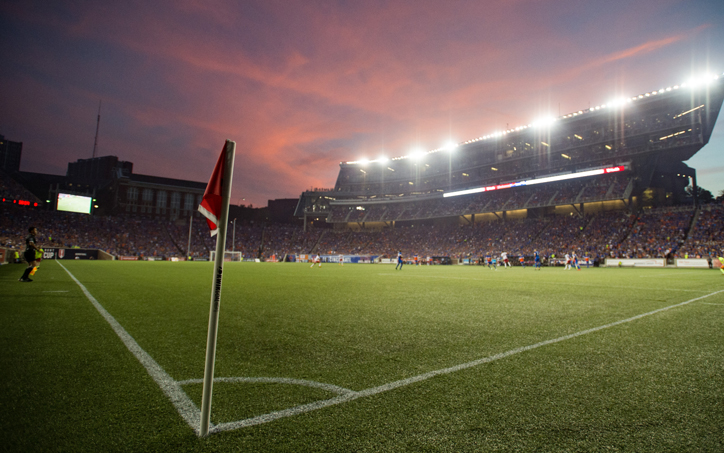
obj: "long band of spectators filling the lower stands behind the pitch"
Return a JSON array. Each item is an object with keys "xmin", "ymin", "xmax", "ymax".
[{"xmin": 0, "ymin": 200, "xmax": 724, "ymax": 260}]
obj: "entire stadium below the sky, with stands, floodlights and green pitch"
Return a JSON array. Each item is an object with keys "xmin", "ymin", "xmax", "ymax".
[{"xmin": 0, "ymin": 75, "xmax": 724, "ymax": 452}]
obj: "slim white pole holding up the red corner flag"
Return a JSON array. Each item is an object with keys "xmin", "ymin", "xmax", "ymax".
[{"xmin": 199, "ymin": 140, "xmax": 236, "ymax": 437}]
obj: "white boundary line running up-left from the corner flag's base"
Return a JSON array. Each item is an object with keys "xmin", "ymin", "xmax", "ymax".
[{"xmin": 55, "ymin": 260, "xmax": 201, "ymax": 436}]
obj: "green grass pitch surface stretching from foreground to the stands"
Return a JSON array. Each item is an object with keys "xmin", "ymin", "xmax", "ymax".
[{"xmin": 0, "ymin": 261, "xmax": 724, "ymax": 452}]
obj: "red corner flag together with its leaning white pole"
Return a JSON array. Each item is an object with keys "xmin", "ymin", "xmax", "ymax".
[{"xmin": 199, "ymin": 140, "xmax": 236, "ymax": 437}]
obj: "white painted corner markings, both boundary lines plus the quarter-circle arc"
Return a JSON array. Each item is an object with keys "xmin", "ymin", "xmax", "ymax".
[{"xmin": 56, "ymin": 261, "xmax": 724, "ymax": 435}]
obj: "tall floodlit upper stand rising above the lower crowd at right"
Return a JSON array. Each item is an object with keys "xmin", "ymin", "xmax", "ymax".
[{"xmin": 295, "ymin": 75, "xmax": 724, "ymax": 228}]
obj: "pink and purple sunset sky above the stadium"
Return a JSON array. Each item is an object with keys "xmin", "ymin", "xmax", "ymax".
[{"xmin": 0, "ymin": 0, "xmax": 724, "ymax": 206}]
